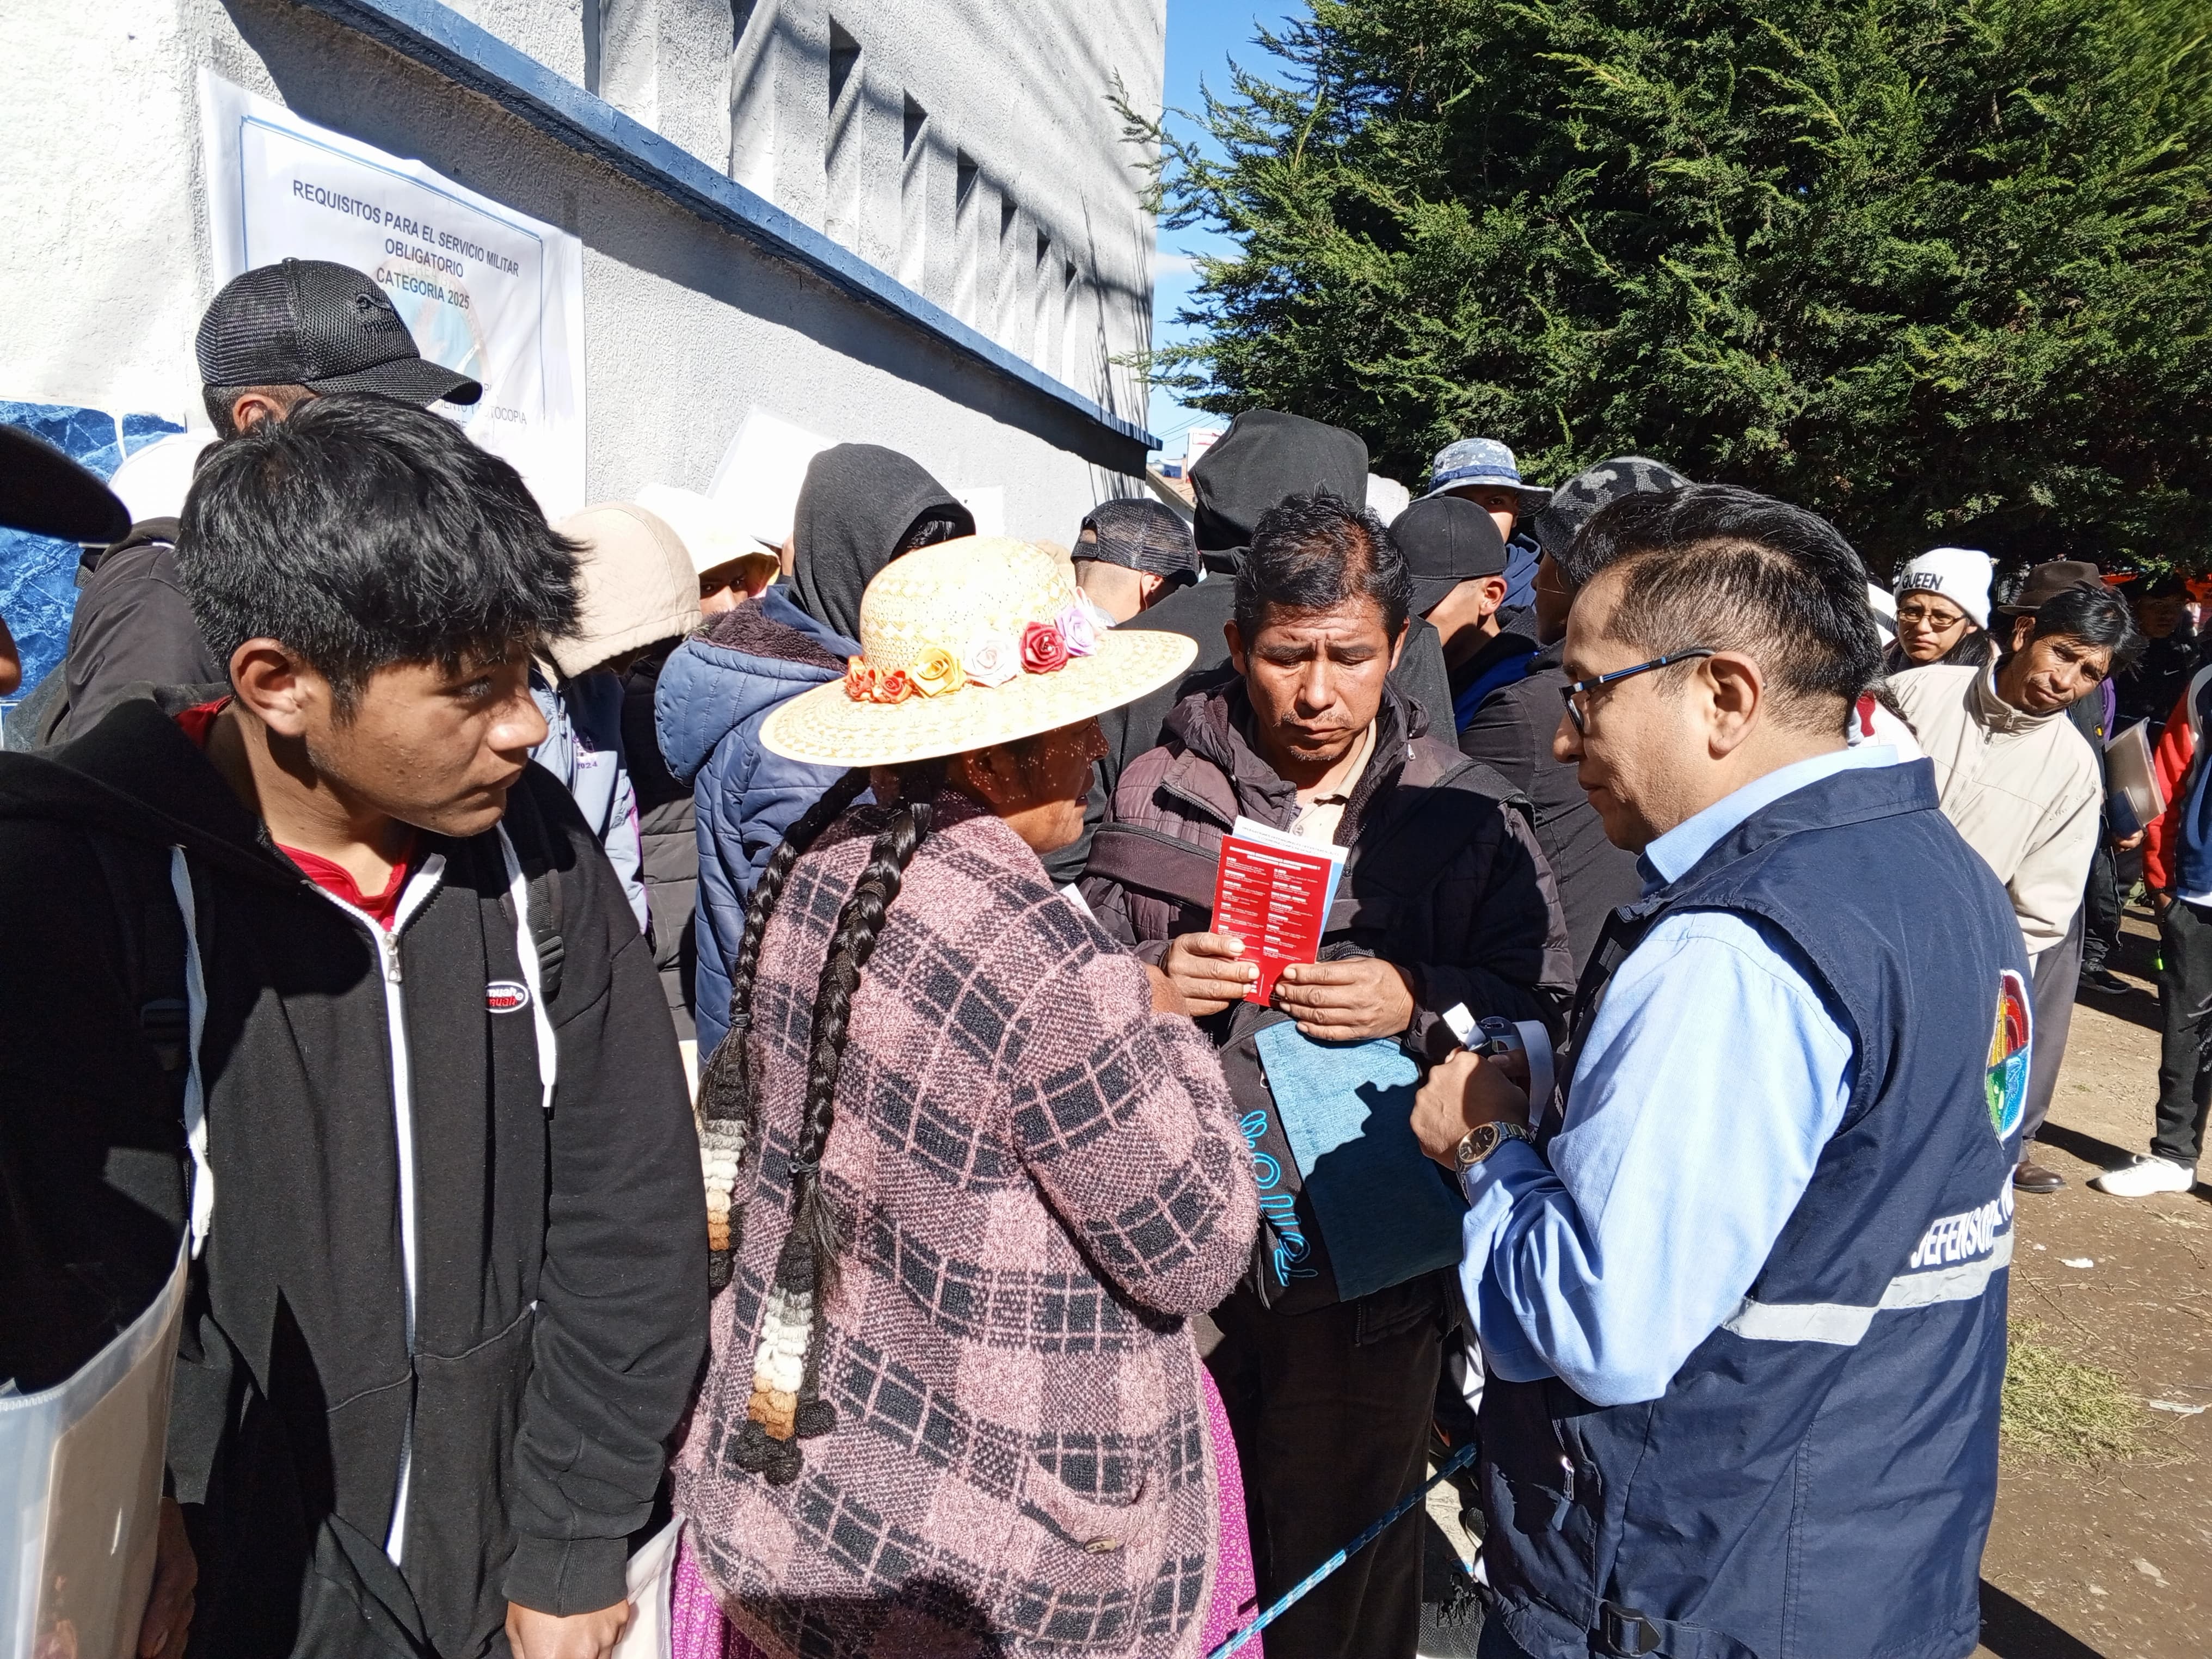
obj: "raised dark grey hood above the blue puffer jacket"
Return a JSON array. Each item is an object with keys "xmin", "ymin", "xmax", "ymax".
[{"xmin": 792, "ymin": 445, "xmax": 975, "ymax": 639}]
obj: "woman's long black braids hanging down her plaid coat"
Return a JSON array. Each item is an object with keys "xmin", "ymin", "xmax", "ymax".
[{"xmin": 717, "ymin": 761, "xmax": 944, "ymax": 1484}]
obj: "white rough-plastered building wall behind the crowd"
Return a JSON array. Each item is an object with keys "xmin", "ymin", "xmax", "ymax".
[{"xmin": 0, "ymin": 0, "xmax": 1166, "ymax": 540}]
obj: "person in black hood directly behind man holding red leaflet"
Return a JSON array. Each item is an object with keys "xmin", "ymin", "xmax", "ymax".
[{"xmin": 1044, "ymin": 409, "xmax": 1451, "ymax": 883}]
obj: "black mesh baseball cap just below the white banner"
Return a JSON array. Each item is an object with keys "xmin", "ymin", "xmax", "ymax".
[{"xmin": 193, "ymin": 259, "xmax": 484, "ymax": 405}]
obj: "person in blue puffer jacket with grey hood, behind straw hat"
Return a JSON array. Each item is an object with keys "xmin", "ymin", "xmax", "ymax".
[{"xmin": 653, "ymin": 445, "xmax": 975, "ymax": 1064}]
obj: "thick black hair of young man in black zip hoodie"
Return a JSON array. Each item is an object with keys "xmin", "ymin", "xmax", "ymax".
[{"xmin": 177, "ymin": 396, "xmax": 582, "ymax": 715}]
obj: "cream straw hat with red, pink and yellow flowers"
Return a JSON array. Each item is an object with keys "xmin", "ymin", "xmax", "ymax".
[{"xmin": 761, "ymin": 535, "xmax": 1199, "ymax": 765}]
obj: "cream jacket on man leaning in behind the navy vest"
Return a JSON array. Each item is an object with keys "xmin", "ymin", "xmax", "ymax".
[{"xmin": 1889, "ymin": 663, "xmax": 2104, "ymax": 956}]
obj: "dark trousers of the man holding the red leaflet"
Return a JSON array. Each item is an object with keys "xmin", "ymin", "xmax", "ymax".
[{"xmin": 1206, "ymin": 1272, "xmax": 1451, "ymax": 1659}]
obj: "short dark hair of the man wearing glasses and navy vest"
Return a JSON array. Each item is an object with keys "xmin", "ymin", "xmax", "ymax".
[{"xmin": 1575, "ymin": 484, "xmax": 1882, "ymax": 726}]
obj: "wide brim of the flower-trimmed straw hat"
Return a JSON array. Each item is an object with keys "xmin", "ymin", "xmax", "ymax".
[{"xmin": 761, "ymin": 628, "xmax": 1199, "ymax": 765}]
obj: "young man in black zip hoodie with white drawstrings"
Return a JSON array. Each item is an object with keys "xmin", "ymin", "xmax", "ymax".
[{"xmin": 0, "ymin": 396, "xmax": 705, "ymax": 1659}]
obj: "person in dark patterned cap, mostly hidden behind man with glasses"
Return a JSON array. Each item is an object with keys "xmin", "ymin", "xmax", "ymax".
[{"xmin": 1460, "ymin": 456, "xmax": 1690, "ymax": 971}]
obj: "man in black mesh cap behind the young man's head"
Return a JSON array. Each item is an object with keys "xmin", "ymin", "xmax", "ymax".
[{"xmin": 27, "ymin": 259, "xmax": 484, "ymax": 746}]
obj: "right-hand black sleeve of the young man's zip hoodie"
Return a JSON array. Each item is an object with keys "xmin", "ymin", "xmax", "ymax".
[{"xmin": 505, "ymin": 785, "xmax": 705, "ymax": 1615}]
